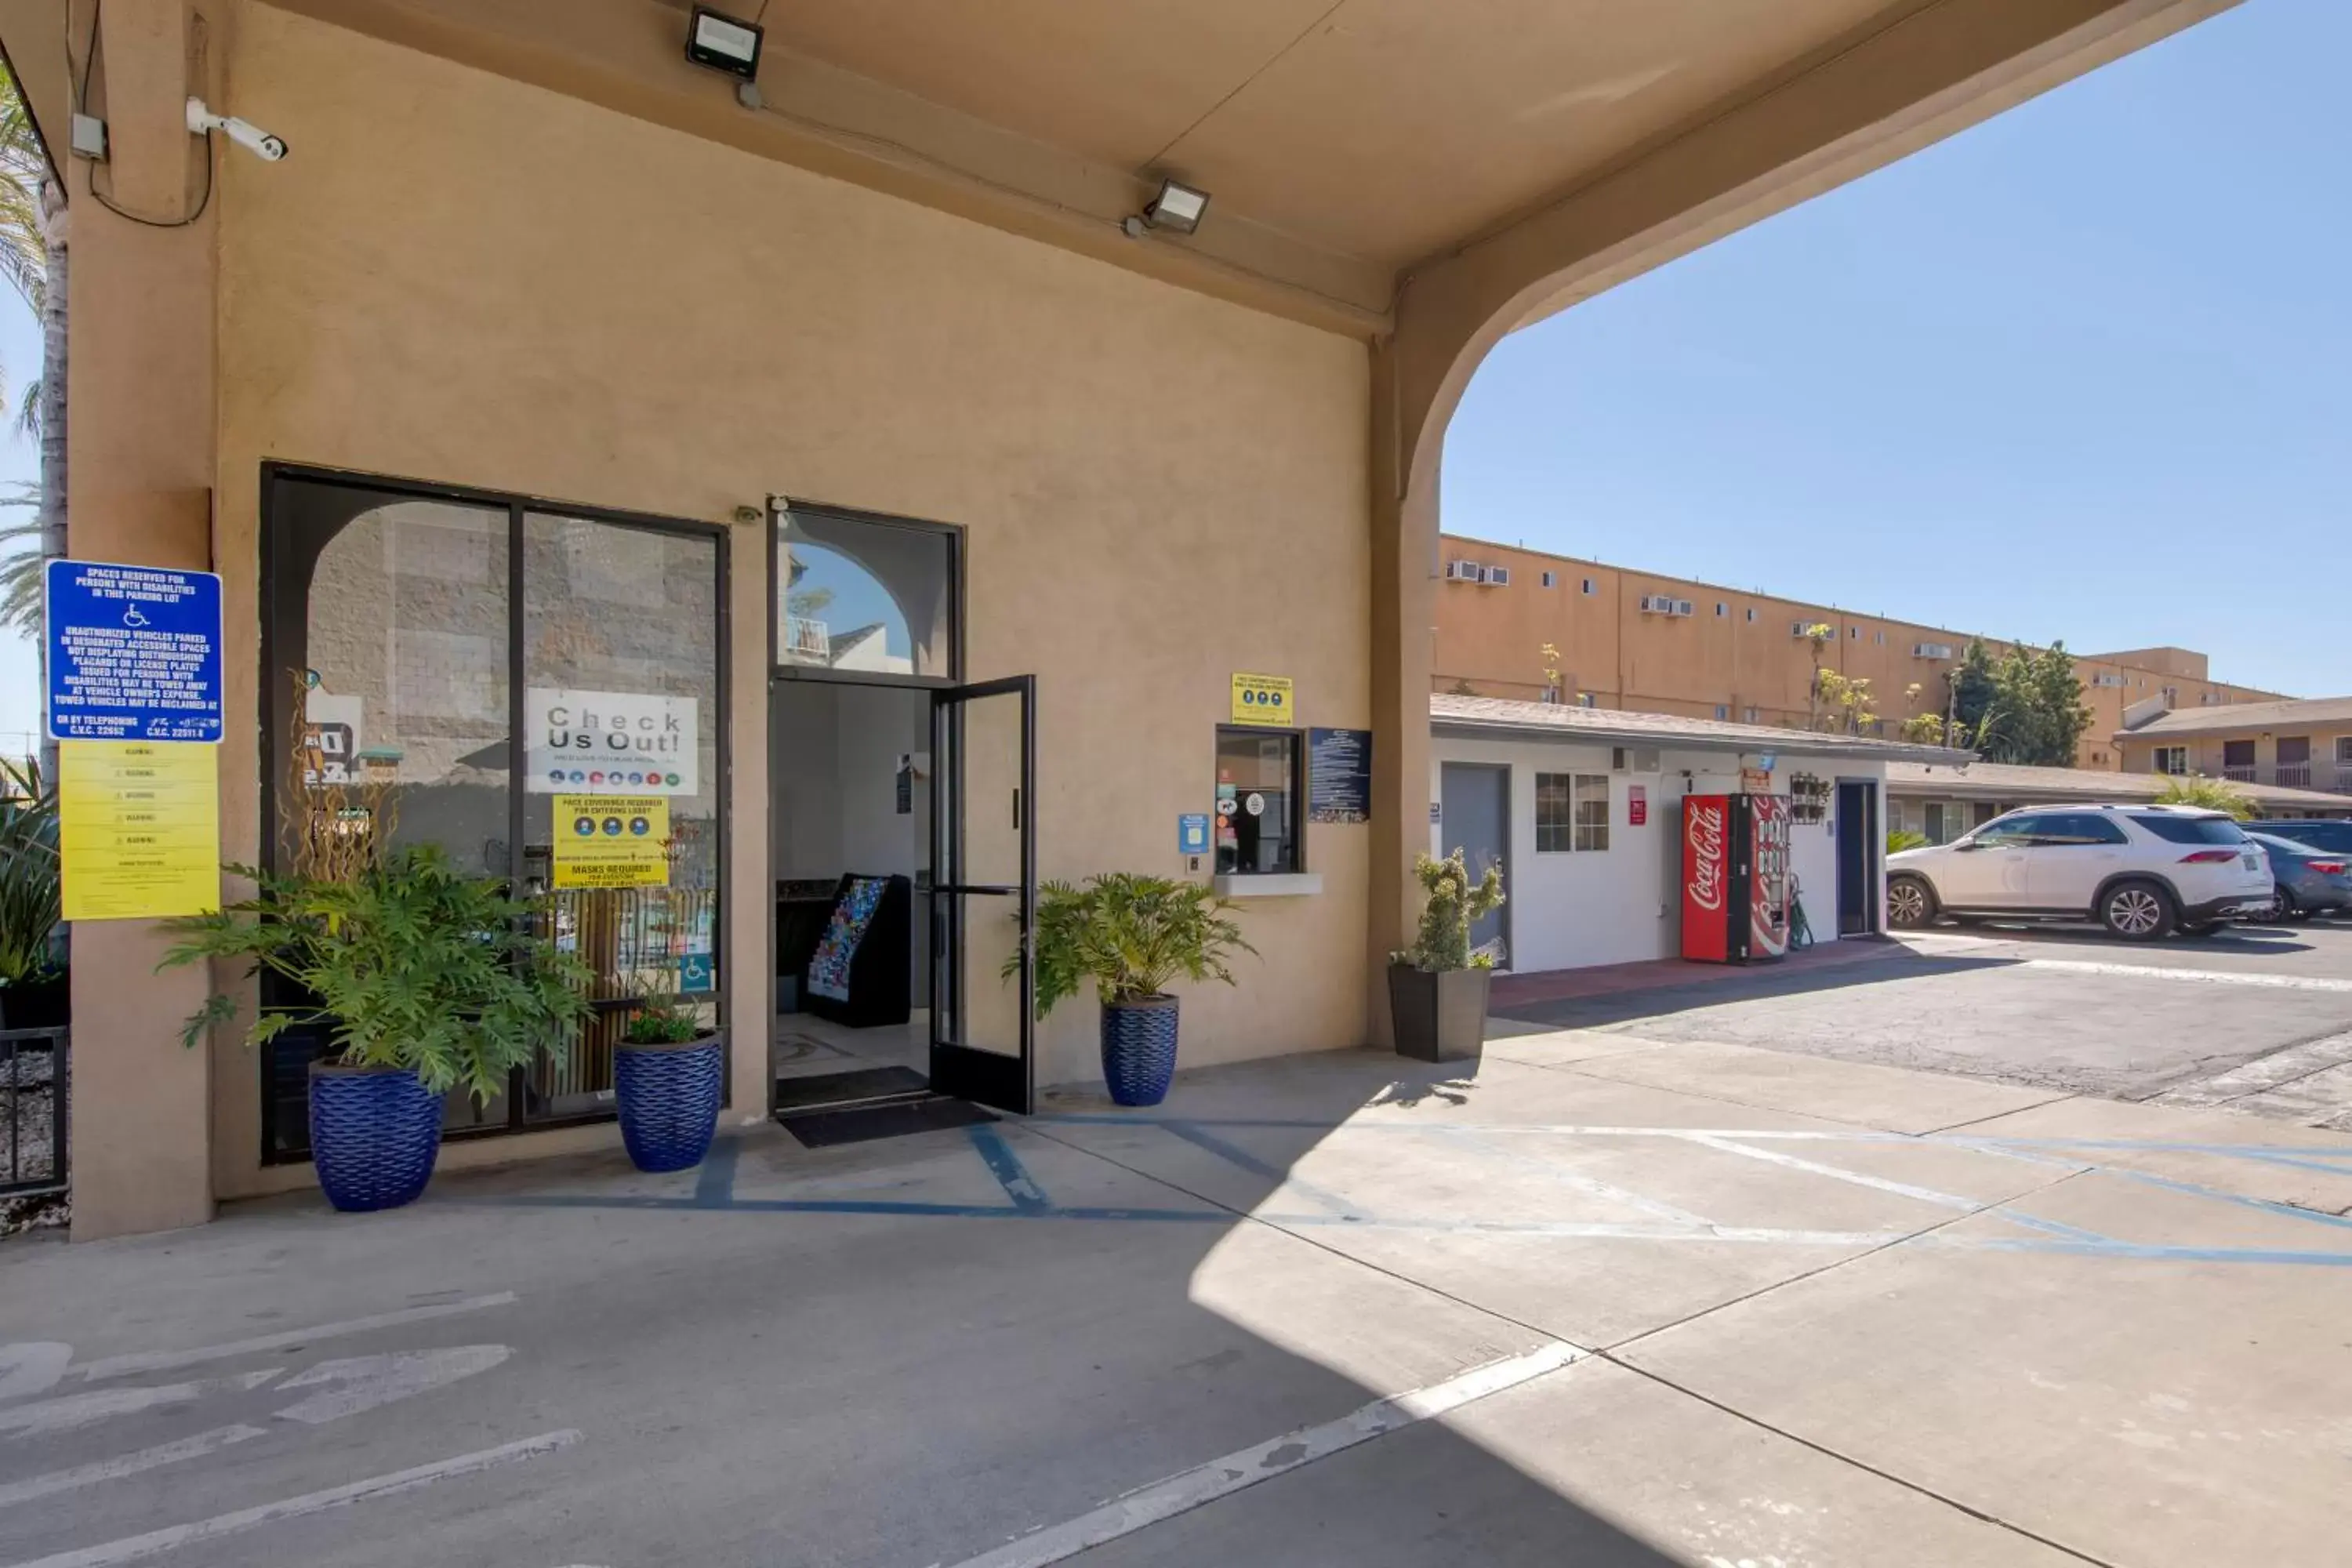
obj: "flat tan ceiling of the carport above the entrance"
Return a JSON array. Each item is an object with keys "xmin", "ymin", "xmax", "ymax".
[{"xmin": 767, "ymin": 0, "xmax": 1917, "ymax": 266}]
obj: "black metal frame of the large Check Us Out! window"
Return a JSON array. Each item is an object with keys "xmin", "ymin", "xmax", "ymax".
[{"xmin": 254, "ymin": 459, "xmax": 734, "ymax": 1166}]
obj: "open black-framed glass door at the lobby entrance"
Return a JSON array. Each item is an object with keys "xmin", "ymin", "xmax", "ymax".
[{"xmin": 931, "ymin": 675, "xmax": 1037, "ymax": 1114}]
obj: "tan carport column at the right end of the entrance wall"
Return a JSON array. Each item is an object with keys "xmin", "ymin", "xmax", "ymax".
[{"xmin": 1364, "ymin": 341, "xmax": 1437, "ymax": 1046}]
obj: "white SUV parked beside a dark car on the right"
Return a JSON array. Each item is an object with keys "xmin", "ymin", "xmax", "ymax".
[{"xmin": 1886, "ymin": 806, "xmax": 2272, "ymax": 942}]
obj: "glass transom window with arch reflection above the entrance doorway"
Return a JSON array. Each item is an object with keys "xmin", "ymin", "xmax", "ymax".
[{"xmin": 776, "ymin": 508, "xmax": 955, "ymax": 680}]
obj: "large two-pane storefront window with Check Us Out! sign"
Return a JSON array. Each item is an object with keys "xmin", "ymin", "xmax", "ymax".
[{"xmin": 261, "ymin": 470, "xmax": 727, "ymax": 1161}]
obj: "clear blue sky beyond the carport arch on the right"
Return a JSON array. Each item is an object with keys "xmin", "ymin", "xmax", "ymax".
[{"xmin": 1442, "ymin": 0, "xmax": 2352, "ymax": 696}]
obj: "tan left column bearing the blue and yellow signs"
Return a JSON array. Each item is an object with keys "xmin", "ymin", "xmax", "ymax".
[{"xmin": 59, "ymin": 0, "xmax": 226, "ymax": 1241}]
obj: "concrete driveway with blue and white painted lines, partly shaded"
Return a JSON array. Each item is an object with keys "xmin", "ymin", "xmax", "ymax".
[{"xmin": 0, "ymin": 1032, "xmax": 2352, "ymax": 1568}]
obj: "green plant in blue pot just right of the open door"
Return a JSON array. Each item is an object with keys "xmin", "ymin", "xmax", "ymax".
[{"xmin": 1004, "ymin": 872, "xmax": 1256, "ymax": 1105}]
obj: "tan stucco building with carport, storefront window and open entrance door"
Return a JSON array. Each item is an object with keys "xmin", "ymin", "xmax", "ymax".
[{"xmin": 18, "ymin": 0, "xmax": 2258, "ymax": 1236}]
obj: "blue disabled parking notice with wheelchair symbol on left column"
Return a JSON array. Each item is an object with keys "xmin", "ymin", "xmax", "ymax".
[{"xmin": 42, "ymin": 560, "xmax": 221, "ymax": 743}]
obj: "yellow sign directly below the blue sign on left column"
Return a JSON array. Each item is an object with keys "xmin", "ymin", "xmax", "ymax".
[{"xmin": 56, "ymin": 741, "xmax": 221, "ymax": 919}]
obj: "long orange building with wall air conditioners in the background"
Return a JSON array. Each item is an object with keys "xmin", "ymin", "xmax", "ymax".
[{"xmin": 1430, "ymin": 534, "xmax": 2277, "ymax": 769}]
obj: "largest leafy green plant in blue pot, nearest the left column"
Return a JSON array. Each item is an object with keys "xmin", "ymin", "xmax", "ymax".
[{"xmin": 162, "ymin": 846, "xmax": 590, "ymax": 1210}]
